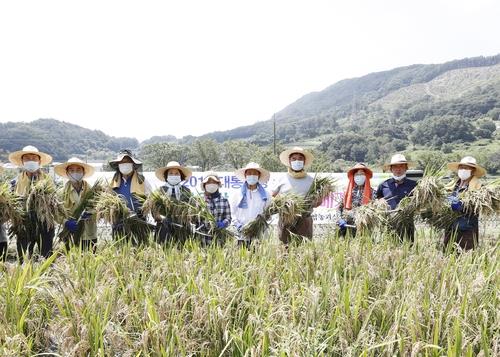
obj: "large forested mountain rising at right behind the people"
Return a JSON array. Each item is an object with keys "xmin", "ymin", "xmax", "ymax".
[{"xmin": 194, "ymin": 54, "xmax": 500, "ymax": 162}]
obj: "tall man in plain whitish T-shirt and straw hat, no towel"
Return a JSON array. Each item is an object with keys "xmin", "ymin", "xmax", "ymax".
[{"xmin": 271, "ymin": 147, "xmax": 321, "ymax": 244}]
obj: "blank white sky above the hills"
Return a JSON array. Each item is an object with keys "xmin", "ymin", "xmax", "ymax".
[{"xmin": 0, "ymin": 0, "xmax": 500, "ymax": 140}]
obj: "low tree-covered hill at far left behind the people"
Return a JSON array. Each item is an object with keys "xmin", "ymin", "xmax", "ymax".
[{"xmin": 0, "ymin": 119, "xmax": 139, "ymax": 161}]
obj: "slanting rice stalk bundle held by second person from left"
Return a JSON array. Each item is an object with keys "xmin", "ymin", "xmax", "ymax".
[{"xmin": 59, "ymin": 180, "xmax": 106, "ymax": 243}]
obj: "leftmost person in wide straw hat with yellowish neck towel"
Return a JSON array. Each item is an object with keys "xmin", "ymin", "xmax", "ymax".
[{"xmin": 9, "ymin": 145, "xmax": 55, "ymax": 262}]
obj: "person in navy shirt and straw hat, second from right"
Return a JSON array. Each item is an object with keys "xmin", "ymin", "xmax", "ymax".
[{"xmin": 376, "ymin": 154, "xmax": 417, "ymax": 243}]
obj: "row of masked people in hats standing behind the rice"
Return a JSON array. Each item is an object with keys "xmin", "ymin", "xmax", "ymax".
[{"xmin": 0, "ymin": 146, "xmax": 486, "ymax": 259}]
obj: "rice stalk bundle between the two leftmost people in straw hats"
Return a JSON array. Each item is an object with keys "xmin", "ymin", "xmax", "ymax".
[{"xmin": 26, "ymin": 177, "xmax": 67, "ymax": 229}]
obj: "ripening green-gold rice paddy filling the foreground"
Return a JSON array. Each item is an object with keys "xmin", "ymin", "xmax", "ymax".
[{"xmin": 0, "ymin": 227, "xmax": 500, "ymax": 356}]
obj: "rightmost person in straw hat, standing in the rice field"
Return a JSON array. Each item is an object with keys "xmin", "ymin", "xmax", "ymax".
[{"xmin": 443, "ymin": 156, "xmax": 486, "ymax": 250}]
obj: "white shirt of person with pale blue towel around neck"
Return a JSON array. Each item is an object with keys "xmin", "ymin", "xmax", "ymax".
[{"xmin": 229, "ymin": 189, "xmax": 271, "ymax": 226}]
